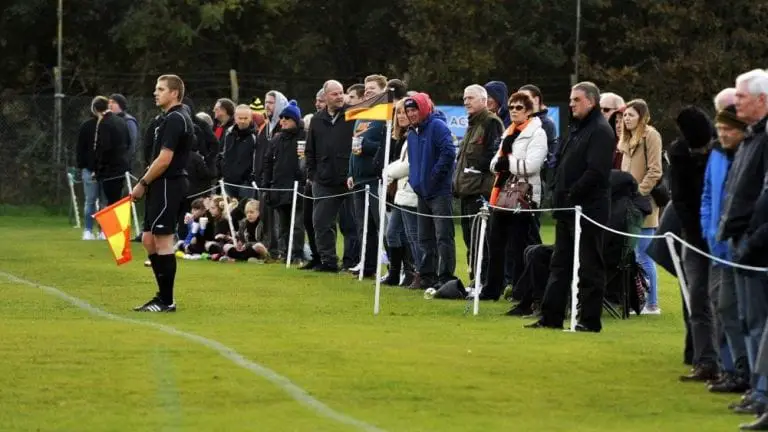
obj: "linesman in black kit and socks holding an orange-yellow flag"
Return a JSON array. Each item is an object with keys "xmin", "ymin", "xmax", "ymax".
[{"xmin": 131, "ymin": 75, "xmax": 195, "ymax": 312}]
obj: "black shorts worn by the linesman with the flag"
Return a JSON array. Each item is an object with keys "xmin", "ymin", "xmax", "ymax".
[{"xmin": 144, "ymin": 177, "xmax": 189, "ymax": 235}]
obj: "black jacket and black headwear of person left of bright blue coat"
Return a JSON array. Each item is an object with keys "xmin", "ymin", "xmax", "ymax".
[{"xmin": 669, "ymin": 107, "xmax": 714, "ymax": 250}]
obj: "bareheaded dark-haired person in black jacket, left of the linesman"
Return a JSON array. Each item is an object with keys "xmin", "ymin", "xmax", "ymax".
[{"xmin": 93, "ymin": 97, "xmax": 131, "ymax": 205}]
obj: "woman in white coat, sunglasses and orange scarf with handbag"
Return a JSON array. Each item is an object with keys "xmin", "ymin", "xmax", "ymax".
[{"xmin": 480, "ymin": 92, "xmax": 547, "ymax": 300}]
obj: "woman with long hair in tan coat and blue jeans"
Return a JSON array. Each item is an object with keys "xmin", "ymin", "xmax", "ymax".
[{"xmin": 619, "ymin": 99, "xmax": 662, "ymax": 315}]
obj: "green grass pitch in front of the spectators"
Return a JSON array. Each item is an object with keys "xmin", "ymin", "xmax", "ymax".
[{"xmin": 0, "ymin": 216, "xmax": 748, "ymax": 431}]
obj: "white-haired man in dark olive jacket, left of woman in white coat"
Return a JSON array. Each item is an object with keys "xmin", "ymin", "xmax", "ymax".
[{"xmin": 453, "ymin": 84, "xmax": 506, "ymax": 284}]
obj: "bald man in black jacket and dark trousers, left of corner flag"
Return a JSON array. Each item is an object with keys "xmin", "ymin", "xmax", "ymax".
[{"xmin": 306, "ymin": 80, "xmax": 354, "ymax": 272}]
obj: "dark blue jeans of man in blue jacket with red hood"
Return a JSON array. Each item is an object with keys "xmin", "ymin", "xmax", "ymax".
[{"xmin": 417, "ymin": 195, "xmax": 456, "ymax": 281}]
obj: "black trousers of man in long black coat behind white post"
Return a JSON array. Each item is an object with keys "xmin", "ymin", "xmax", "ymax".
[{"xmin": 541, "ymin": 220, "xmax": 605, "ymax": 330}]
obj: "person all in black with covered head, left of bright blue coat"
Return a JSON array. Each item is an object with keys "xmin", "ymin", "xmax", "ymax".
[{"xmin": 669, "ymin": 107, "xmax": 719, "ymax": 381}]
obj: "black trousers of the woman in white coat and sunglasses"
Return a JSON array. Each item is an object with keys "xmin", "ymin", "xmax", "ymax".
[{"xmin": 483, "ymin": 210, "xmax": 535, "ymax": 300}]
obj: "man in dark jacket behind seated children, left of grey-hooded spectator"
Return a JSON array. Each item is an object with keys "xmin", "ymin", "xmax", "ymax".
[{"xmin": 220, "ymin": 105, "xmax": 256, "ymax": 200}]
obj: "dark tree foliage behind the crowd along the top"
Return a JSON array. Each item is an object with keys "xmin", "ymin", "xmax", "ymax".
[{"xmin": 0, "ymin": 0, "xmax": 768, "ymax": 128}]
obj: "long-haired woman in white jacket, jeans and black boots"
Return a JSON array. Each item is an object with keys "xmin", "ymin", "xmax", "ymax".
[{"xmin": 384, "ymin": 101, "xmax": 421, "ymax": 288}]
